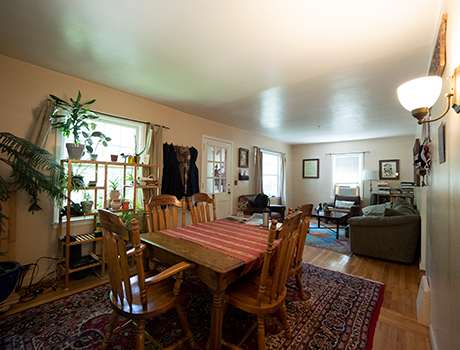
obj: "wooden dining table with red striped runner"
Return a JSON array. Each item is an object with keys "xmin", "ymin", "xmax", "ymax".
[{"xmin": 141, "ymin": 219, "xmax": 268, "ymax": 350}]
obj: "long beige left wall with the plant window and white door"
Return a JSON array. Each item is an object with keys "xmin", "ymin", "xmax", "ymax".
[{"xmin": 0, "ymin": 55, "xmax": 291, "ymax": 270}]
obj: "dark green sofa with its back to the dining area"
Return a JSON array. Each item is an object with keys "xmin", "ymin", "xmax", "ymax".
[{"xmin": 348, "ymin": 198, "xmax": 420, "ymax": 264}]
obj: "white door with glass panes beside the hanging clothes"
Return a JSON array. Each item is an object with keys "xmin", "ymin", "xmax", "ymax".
[{"xmin": 201, "ymin": 136, "xmax": 233, "ymax": 219}]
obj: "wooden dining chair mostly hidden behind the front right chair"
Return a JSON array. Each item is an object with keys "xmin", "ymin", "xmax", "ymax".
[{"xmin": 288, "ymin": 204, "xmax": 313, "ymax": 300}]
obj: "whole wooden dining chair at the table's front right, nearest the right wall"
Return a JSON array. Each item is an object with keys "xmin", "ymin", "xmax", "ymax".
[{"xmin": 222, "ymin": 212, "xmax": 301, "ymax": 350}]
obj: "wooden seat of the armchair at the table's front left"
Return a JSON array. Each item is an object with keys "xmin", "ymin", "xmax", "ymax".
[{"xmin": 110, "ymin": 276, "xmax": 189, "ymax": 319}]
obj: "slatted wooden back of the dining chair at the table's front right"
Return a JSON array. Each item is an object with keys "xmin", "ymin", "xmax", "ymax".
[{"xmin": 256, "ymin": 212, "xmax": 301, "ymax": 306}]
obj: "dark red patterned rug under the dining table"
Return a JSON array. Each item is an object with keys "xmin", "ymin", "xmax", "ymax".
[{"xmin": 0, "ymin": 264, "xmax": 384, "ymax": 350}]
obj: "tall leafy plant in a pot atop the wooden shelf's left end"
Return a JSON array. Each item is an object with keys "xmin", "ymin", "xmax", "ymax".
[{"xmin": 50, "ymin": 91, "xmax": 105, "ymax": 159}]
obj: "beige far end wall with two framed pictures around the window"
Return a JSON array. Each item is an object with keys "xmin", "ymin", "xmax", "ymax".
[{"xmin": 292, "ymin": 136, "xmax": 414, "ymax": 207}]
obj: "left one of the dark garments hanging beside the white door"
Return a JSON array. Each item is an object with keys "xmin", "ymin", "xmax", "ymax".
[{"xmin": 161, "ymin": 143, "xmax": 185, "ymax": 200}]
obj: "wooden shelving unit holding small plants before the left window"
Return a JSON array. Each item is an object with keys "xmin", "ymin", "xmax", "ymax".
[{"xmin": 58, "ymin": 159, "xmax": 161, "ymax": 289}]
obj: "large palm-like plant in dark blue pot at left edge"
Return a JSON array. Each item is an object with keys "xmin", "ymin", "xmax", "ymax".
[{"xmin": 0, "ymin": 132, "xmax": 65, "ymax": 303}]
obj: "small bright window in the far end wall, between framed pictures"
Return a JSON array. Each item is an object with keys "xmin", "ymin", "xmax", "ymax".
[{"xmin": 331, "ymin": 153, "xmax": 363, "ymax": 197}]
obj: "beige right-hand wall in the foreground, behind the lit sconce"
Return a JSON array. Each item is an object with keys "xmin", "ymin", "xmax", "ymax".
[{"xmin": 417, "ymin": 0, "xmax": 460, "ymax": 350}]
